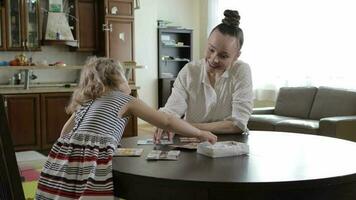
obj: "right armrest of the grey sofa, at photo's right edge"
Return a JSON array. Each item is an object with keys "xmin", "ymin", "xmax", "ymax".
[{"xmin": 319, "ymin": 115, "xmax": 356, "ymax": 142}]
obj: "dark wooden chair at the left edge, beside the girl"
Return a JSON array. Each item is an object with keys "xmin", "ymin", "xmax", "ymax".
[{"xmin": 0, "ymin": 95, "xmax": 25, "ymax": 200}]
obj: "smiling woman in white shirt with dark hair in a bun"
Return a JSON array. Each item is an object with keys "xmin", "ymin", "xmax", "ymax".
[{"xmin": 154, "ymin": 10, "xmax": 253, "ymax": 143}]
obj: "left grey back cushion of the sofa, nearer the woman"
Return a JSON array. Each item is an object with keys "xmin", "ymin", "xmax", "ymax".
[{"xmin": 275, "ymin": 87, "xmax": 317, "ymax": 119}]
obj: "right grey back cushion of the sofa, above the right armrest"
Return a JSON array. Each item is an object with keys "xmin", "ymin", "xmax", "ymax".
[{"xmin": 310, "ymin": 87, "xmax": 356, "ymax": 119}]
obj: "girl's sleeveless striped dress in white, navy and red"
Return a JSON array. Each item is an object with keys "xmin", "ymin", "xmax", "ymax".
[{"xmin": 36, "ymin": 91, "xmax": 133, "ymax": 200}]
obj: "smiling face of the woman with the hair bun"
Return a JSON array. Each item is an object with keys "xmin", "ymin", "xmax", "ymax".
[{"xmin": 205, "ymin": 30, "xmax": 240, "ymax": 70}]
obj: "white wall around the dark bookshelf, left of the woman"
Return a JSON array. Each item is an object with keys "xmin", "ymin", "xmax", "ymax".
[{"xmin": 135, "ymin": 0, "xmax": 205, "ymax": 123}]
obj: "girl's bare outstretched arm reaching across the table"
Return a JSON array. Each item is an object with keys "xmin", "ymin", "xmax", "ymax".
[{"xmin": 123, "ymin": 99, "xmax": 217, "ymax": 143}]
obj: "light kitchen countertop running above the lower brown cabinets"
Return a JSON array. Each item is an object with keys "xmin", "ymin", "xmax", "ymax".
[{"xmin": 0, "ymin": 83, "xmax": 139, "ymax": 94}]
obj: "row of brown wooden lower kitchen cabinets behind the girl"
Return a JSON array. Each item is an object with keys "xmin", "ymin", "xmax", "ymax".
[{"xmin": 4, "ymin": 90, "xmax": 137, "ymax": 152}]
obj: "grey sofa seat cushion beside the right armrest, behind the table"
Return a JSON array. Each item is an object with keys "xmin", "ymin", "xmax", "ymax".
[{"xmin": 275, "ymin": 119, "xmax": 319, "ymax": 134}]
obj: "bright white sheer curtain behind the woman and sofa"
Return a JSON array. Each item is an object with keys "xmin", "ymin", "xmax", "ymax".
[{"xmin": 208, "ymin": 0, "xmax": 356, "ymax": 100}]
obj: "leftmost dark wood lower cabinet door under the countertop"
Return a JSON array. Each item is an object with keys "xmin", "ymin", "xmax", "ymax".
[{"xmin": 4, "ymin": 94, "xmax": 41, "ymax": 151}]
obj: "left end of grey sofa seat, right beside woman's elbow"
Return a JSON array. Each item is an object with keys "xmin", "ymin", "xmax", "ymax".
[{"xmin": 247, "ymin": 114, "xmax": 294, "ymax": 131}]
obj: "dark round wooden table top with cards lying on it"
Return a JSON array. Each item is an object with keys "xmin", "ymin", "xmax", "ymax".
[{"xmin": 113, "ymin": 131, "xmax": 356, "ymax": 184}]
